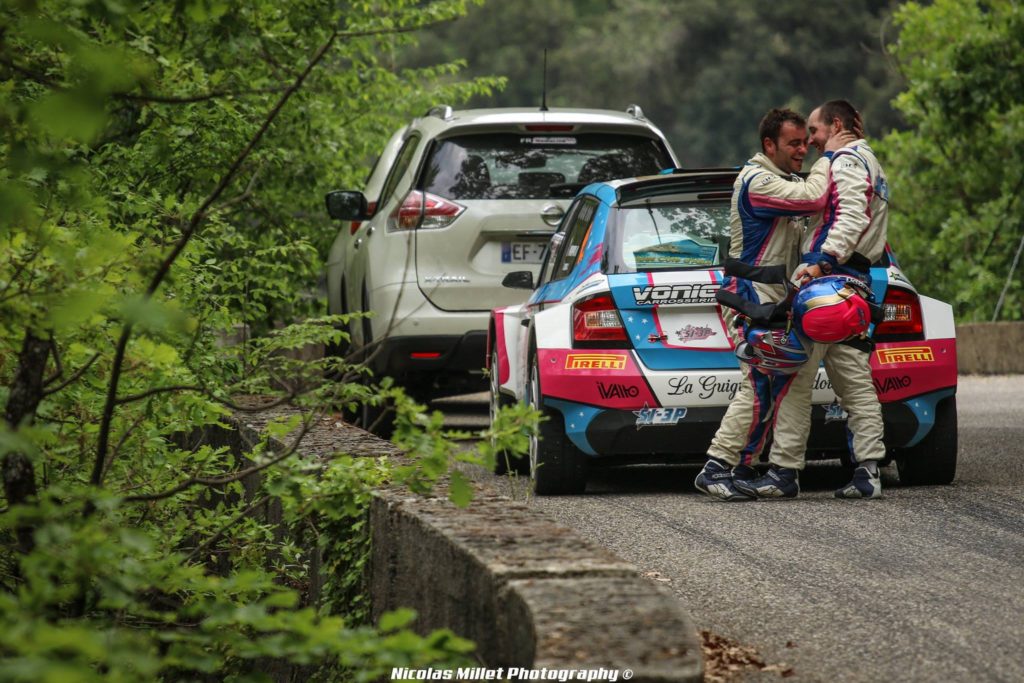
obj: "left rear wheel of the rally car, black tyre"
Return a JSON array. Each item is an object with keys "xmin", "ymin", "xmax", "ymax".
[{"xmin": 528, "ymin": 357, "xmax": 587, "ymax": 496}]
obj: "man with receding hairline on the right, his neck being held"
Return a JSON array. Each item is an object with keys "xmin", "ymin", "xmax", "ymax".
[{"xmin": 738, "ymin": 100, "xmax": 889, "ymax": 498}]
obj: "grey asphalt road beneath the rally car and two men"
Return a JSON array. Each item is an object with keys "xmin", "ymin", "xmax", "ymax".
[{"xmin": 445, "ymin": 376, "xmax": 1024, "ymax": 683}]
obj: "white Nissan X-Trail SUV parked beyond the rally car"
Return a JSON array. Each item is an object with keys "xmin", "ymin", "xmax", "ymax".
[{"xmin": 326, "ymin": 105, "xmax": 678, "ymax": 398}]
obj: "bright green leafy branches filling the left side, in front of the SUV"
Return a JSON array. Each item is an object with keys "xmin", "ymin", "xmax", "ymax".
[{"xmin": 0, "ymin": 0, "xmax": 528, "ymax": 682}]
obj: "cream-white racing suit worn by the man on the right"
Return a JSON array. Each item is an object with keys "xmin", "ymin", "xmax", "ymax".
[{"xmin": 794, "ymin": 140, "xmax": 889, "ymax": 467}]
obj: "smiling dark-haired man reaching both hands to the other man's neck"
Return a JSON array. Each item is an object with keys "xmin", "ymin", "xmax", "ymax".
[{"xmin": 694, "ymin": 109, "xmax": 854, "ymax": 501}]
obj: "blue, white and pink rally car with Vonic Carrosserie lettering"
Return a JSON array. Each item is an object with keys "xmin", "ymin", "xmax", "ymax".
[{"xmin": 488, "ymin": 169, "xmax": 956, "ymax": 495}]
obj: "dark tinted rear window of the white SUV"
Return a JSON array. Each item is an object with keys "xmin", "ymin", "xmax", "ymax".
[{"xmin": 424, "ymin": 133, "xmax": 672, "ymax": 200}]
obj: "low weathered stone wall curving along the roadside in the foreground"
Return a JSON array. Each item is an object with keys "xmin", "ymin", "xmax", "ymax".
[{"xmin": 223, "ymin": 409, "xmax": 703, "ymax": 683}]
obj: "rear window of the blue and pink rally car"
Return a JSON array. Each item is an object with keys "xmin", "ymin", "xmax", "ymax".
[{"xmin": 612, "ymin": 203, "xmax": 729, "ymax": 272}]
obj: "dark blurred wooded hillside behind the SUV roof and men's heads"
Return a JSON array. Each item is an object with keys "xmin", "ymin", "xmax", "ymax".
[{"xmin": 410, "ymin": 0, "xmax": 901, "ymax": 167}]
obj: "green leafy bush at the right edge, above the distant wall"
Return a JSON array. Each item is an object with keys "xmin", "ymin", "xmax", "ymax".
[{"xmin": 880, "ymin": 0, "xmax": 1024, "ymax": 321}]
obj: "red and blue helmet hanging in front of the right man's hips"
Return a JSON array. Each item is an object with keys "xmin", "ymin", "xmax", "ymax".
[{"xmin": 793, "ymin": 275, "xmax": 871, "ymax": 344}]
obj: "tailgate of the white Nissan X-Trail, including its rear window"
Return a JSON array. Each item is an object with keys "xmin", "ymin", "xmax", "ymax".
[{"xmin": 407, "ymin": 126, "xmax": 673, "ymax": 310}]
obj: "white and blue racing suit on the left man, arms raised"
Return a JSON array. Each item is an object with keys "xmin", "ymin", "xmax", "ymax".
[{"xmin": 708, "ymin": 154, "xmax": 828, "ymax": 467}]
